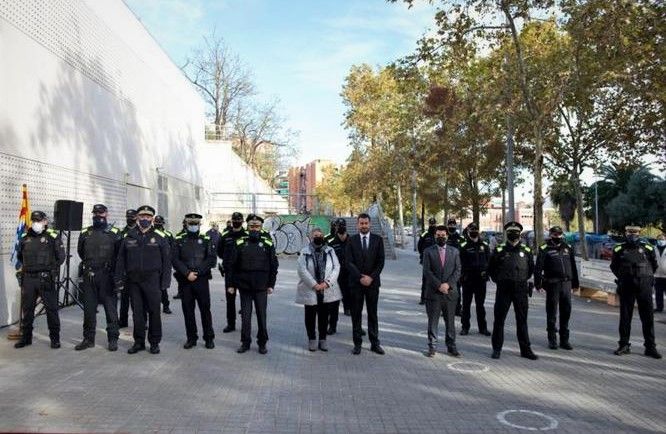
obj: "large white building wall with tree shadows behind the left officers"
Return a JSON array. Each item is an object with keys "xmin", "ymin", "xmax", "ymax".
[{"xmin": 0, "ymin": 0, "xmax": 205, "ymax": 325}]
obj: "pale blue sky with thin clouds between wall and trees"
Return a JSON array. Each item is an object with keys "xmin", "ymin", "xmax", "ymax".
[{"xmin": 125, "ymin": 0, "xmax": 434, "ymax": 164}]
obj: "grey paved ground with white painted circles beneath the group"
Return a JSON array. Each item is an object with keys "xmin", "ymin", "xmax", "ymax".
[{"xmin": 0, "ymin": 254, "xmax": 666, "ymax": 433}]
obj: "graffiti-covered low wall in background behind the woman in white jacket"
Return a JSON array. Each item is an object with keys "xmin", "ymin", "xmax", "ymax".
[{"xmin": 264, "ymin": 215, "xmax": 331, "ymax": 255}]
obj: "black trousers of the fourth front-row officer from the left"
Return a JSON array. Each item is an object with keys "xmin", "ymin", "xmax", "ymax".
[{"xmin": 178, "ymin": 277, "xmax": 215, "ymax": 341}]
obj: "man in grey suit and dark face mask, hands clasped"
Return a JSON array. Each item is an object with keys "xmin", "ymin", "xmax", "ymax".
[{"xmin": 423, "ymin": 225, "xmax": 461, "ymax": 357}]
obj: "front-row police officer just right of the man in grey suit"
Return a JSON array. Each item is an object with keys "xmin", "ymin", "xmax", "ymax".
[{"xmin": 488, "ymin": 222, "xmax": 538, "ymax": 360}]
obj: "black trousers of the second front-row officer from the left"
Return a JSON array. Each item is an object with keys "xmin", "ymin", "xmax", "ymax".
[{"xmin": 82, "ymin": 270, "xmax": 120, "ymax": 342}]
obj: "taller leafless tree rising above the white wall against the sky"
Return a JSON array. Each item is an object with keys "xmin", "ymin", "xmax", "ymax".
[{"xmin": 182, "ymin": 30, "xmax": 255, "ymax": 139}]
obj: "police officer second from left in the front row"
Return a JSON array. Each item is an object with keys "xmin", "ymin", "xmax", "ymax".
[{"xmin": 74, "ymin": 203, "xmax": 121, "ymax": 351}]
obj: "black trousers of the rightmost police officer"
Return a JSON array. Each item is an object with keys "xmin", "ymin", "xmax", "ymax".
[{"xmin": 618, "ymin": 285, "xmax": 657, "ymax": 348}]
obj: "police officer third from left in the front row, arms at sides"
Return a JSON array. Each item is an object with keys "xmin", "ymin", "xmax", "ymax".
[{"xmin": 115, "ymin": 205, "xmax": 171, "ymax": 354}]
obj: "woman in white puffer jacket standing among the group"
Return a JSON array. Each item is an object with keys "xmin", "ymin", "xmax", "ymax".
[{"xmin": 296, "ymin": 228, "xmax": 342, "ymax": 351}]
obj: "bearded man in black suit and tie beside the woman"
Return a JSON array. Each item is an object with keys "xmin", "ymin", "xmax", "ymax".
[{"xmin": 345, "ymin": 213, "xmax": 384, "ymax": 355}]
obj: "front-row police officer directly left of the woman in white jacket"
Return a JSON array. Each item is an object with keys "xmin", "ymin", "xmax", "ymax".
[{"xmin": 224, "ymin": 216, "xmax": 278, "ymax": 354}]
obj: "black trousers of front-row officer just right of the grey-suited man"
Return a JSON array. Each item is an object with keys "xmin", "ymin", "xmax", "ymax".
[{"xmin": 492, "ymin": 282, "xmax": 530, "ymax": 352}]
